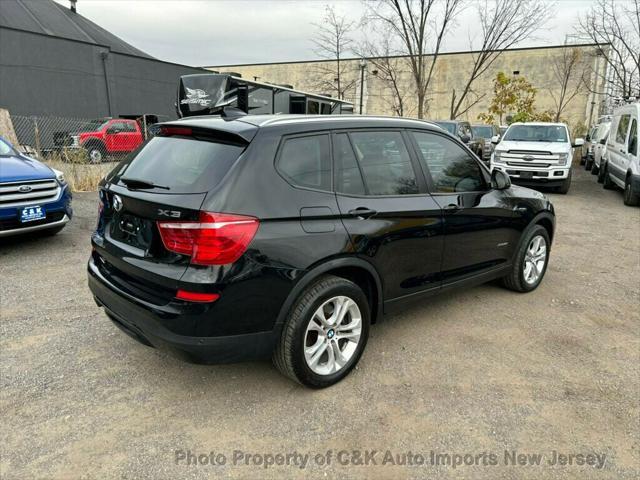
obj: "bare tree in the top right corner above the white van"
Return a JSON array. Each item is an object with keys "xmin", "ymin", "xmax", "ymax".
[{"xmin": 578, "ymin": 0, "xmax": 640, "ymax": 98}]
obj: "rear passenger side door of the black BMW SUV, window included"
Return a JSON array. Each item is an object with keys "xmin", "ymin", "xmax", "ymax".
[{"xmin": 333, "ymin": 130, "xmax": 442, "ymax": 300}]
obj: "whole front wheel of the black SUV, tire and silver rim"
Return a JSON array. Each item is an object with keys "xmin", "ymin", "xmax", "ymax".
[{"xmin": 502, "ymin": 225, "xmax": 551, "ymax": 293}]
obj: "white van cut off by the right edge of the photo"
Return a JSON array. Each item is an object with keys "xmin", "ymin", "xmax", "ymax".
[{"xmin": 603, "ymin": 103, "xmax": 640, "ymax": 206}]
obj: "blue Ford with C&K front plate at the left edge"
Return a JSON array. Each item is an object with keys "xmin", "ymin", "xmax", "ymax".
[{"xmin": 0, "ymin": 137, "xmax": 73, "ymax": 237}]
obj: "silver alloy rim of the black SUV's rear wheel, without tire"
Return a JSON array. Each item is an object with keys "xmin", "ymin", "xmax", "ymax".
[{"xmin": 304, "ymin": 296, "xmax": 362, "ymax": 375}]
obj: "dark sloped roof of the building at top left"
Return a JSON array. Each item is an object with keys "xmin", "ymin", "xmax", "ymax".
[{"xmin": 0, "ymin": 0, "xmax": 153, "ymax": 58}]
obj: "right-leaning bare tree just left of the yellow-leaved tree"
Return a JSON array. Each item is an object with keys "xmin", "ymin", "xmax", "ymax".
[{"xmin": 450, "ymin": 0, "xmax": 552, "ymax": 119}]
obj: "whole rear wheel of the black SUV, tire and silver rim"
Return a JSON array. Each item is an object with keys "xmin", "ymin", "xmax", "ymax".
[{"xmin": 273, "ymin": 275, "xmax": 371, "ymax": 388}]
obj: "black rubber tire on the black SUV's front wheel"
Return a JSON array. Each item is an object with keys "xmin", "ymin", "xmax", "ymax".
[{"xmin": 502, "ymin": 225, "xmax": 551, "ymax": 293}]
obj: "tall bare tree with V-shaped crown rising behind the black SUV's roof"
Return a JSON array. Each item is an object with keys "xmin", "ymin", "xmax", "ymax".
[{"xmin": 367, "ymin": 0, "xmax": 463, "ymax": 118}]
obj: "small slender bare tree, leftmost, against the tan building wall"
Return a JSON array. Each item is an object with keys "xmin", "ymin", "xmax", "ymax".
[{"xmin": 312, "ymin": 5, "xmax": 356, "ymax": 99}]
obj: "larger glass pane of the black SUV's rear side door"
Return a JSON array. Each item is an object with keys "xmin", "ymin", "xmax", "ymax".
[{"xmin": 349, "ymin": 130, "xmax": 419, "ymax": 195}]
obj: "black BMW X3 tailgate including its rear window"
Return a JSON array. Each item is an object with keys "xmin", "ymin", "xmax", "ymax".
[{"xmin": 92, "ymin": 131, "xmax": 245, "ymax": 301}]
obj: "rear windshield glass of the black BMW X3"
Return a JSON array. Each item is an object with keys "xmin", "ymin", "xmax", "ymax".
[{"xmin": 116, "ymin": 137, "xmax": 245, "ymax": 193}]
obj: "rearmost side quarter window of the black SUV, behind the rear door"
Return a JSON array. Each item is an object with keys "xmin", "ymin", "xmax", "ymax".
[{"xmin": 277, "ymin": 134, "xmax": 331, "ymax": 191}]
